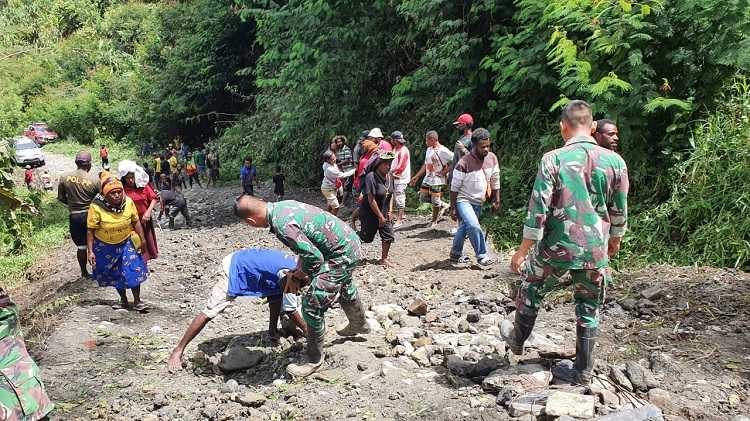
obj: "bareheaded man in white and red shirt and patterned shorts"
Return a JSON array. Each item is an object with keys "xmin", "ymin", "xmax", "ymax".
[{"xmin": 410, "ymin": 130, "xmax": 453, "ymax": 228}]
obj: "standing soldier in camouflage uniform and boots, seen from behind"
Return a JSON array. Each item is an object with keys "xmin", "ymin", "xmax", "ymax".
[{"xmin": 501, "ymin": 101, "xmax": 628, "ymax": 384}]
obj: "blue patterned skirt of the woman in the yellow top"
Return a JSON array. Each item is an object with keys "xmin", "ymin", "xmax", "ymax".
[{"xmin": 92, "ymin": 238, "xmax": 148, "ymax": 289}]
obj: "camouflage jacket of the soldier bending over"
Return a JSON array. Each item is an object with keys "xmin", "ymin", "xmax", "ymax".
[{"xmin": 268, "ymin": 200, "xmax": 364, "ymax": 276}]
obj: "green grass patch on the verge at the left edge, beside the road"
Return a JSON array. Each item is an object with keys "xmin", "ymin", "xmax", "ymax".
[{"xmin": 0, "ymin": 189, "xmax": 68, "ymax": 289}]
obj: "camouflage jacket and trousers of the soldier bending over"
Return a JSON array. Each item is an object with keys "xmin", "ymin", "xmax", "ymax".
[{"xmin": 268, "ymin": 200, "xmax": 364, "ymax": 332}]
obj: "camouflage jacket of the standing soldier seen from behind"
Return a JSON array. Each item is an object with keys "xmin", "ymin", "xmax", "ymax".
[{"xmin": 523, "ymin": 136, "xmax": 629, "ymax": 269}]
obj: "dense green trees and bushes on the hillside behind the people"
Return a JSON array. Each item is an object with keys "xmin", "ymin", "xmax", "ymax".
[{"xmin": 0, "ymin": 0, "xmax": 750, "ymax": 267}]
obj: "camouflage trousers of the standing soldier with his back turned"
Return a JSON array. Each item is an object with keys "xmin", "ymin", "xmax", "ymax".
[{"xmin": 516, "ymin": 256, "xmax": 611, "ymax": 328}]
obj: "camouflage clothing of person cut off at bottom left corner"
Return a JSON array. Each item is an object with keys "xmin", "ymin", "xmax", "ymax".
[{"xmin": 0, "ymin": 288, "xmax": 54, "ymax": 421}]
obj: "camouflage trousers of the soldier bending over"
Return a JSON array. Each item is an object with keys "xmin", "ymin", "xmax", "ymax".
[{"xmin": 302, "ymin": 258, "xmax": 359, "ymax": 332}]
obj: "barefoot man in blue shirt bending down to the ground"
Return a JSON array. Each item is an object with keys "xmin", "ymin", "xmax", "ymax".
[{"xmin": 167, "ymin": 248, "xmax": 307, "ymax": 372}]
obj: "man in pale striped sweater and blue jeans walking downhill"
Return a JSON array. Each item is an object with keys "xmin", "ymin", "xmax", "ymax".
[{"xmin": 450, "ymin": 128, "xmax": 500, "ymax": 267}]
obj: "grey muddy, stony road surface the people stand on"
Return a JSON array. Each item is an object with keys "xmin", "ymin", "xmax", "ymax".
[{"xmin": 10, "ymin": 153, "xmax": 750, "ymax": 420}]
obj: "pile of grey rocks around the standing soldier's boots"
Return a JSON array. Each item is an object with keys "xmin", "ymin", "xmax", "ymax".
[{"xmin": 367, "ymin": 295, "xmax": 671, "ymax": 420}]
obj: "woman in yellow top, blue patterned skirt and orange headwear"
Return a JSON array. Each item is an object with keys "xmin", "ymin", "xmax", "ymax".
[{"xmin": 87, "ymin": 173, "xmax": 148, "ymax": 311}]
